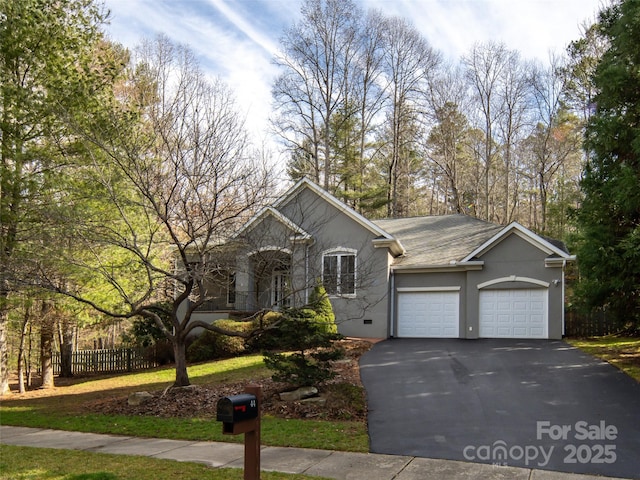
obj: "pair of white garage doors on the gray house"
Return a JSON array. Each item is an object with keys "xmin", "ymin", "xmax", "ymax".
[{"xmin": 397, "ymin": 288, "xmax": 549, "ymax": 339}]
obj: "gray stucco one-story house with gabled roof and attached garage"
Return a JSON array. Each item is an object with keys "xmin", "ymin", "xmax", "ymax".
[{"xmin": 190, "ymin": 179, "xmax": 575, "ymax": 338}]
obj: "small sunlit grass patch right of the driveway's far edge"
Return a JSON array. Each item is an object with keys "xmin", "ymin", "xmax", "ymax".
[{"xmin": 567, "ymin": 335, "xmax": 640, "ymax": 382}]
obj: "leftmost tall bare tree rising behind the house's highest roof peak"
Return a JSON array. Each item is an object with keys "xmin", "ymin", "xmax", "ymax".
[{"xmin": 272, "ymin": 0, "xmax": 360, "ymax": 190}]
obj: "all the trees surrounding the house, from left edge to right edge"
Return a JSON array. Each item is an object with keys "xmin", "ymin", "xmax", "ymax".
[{"xmin": 0, "ymin": 0, "xmax": 640, "ymax": 392}]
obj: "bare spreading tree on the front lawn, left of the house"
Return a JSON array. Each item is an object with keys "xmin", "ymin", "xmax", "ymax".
[{"xmin": 42, "ymin": 37, "xmax": 271, "ymax": 386}]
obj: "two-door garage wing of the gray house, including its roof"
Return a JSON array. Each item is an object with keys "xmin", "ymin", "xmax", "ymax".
[{"xmin": 384, "ymin": 221, "xmax": 575, "ymax": 339}]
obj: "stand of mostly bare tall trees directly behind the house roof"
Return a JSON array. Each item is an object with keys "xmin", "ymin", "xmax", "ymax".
[{"xmin": 272, "ymin": 0, "xmax": 607, "ymax": 239}]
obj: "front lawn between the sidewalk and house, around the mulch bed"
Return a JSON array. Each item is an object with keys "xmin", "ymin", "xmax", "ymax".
[{"xmin": 0, "ymin": 355, "xmax": 369, "ymax": 452}]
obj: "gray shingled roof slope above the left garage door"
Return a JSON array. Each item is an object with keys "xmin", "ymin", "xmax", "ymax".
[{"xmin": 373, "ymin": 214, "xmax": 504, "ymax": 267}]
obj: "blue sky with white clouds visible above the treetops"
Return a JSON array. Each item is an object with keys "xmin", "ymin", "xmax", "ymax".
[{"xmin": 104, "ymin": 0, "xmax": 605, "ymax": 160}]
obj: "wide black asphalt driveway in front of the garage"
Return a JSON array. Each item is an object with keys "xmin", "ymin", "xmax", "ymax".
[{"xmin": 360, "ymin": 339, "xmax": 640, "ymax": 478}]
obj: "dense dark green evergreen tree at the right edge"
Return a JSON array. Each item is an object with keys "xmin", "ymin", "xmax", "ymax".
[{"xmin": 577, "ymin": 0, "xmax": 640, "ymax": 328}]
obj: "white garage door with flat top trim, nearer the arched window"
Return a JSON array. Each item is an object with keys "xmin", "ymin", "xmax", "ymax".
[{"xmin": 398, "ymin": 292, "xmax": 460, "ymax": 338}]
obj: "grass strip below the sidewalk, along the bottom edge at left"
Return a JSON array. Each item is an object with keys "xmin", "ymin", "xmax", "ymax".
[{"xmin": 0, "ymin": 445, "xmax": 330, "ymax": 480}]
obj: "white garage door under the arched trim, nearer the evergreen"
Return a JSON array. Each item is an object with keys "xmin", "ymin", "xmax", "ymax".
[{"xmin": 479, "ymin": 288, "xmax": 549, "ymax": 338}]
